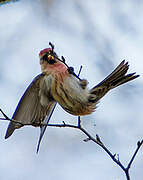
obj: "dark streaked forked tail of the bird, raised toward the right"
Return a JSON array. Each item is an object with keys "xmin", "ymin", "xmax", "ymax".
[{"xmin": 89, "ymin": 60, "xmax": 139, "ymax": 103}]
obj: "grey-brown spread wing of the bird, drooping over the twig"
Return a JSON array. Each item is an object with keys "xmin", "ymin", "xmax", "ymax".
[{"xmin": 5, "ymin": 74, "xmax": 55, "ymax": 138}]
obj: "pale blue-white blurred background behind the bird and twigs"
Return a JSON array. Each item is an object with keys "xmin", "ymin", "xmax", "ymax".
[{"xmin": 0, "ymin": 0, "xmax": 143, "ymax": 180}]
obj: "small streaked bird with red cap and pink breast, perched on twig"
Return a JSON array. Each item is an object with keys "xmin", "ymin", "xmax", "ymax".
[{"xmin": 5, "ymin": 42, "xmax": 139, "ymax": 152}]
